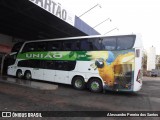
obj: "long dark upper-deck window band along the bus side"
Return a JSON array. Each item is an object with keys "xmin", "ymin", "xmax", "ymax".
[{"xmin": 19, "ymin": 35, "xmax": 136, "ymax": 52}]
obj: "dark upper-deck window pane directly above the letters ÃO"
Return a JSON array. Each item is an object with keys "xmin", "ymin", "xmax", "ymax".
[{"xmin": 47, "ymin": 41, "xmax": 61, "ymax": 51}]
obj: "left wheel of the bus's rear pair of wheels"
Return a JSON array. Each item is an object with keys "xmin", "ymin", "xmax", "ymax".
[{"xmin": 72, "ymin": 77, "xmax": 85, "ymax": 90}]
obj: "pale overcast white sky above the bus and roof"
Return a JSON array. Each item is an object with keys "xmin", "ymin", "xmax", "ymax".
[{"xmin": 58, "ymin": 0, "xmax": 160, "ymax": 55}]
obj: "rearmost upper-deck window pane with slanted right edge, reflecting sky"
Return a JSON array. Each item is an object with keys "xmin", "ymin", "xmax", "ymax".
[{"xmin": 117, "ymin": 36, "xmax": 135, "ymax": 50}]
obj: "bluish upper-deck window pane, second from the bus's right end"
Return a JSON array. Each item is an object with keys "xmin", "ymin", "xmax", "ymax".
[{"xmin": 102, "ymin": 37, "xmax": 116, "ymax": 50}]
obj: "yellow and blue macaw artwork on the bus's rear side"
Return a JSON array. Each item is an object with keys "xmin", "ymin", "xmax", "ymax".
[{"xmin": 81, "ymin": 49, "xmax": 135, "ymax": 91}]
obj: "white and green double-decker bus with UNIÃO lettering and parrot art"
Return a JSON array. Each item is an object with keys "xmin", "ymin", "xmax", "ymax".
[{"xmin": 7, "ymin": 34, "xmax": 142, "ymax": 92}]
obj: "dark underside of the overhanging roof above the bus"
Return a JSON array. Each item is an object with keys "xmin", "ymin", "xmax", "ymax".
[{"xmin": 0, "ymin": 0, "xmax": 98, "ymax": 40}]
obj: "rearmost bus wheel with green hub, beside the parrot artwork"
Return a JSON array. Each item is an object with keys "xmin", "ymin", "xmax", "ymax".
[{"xmin": 88, "ymin": 78, "xmax": 103, "ymax": 93}]
